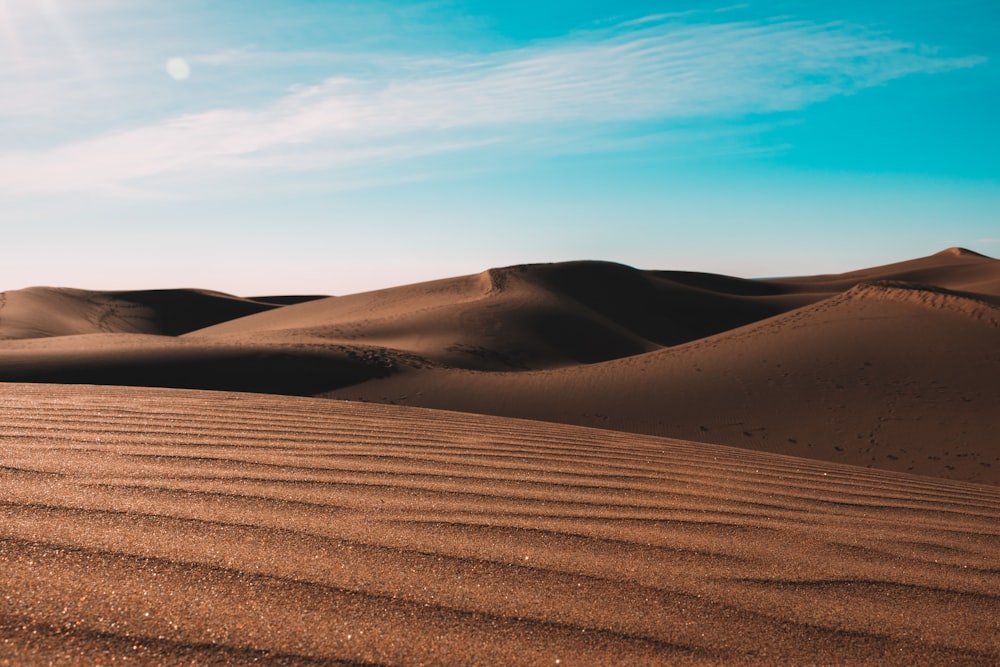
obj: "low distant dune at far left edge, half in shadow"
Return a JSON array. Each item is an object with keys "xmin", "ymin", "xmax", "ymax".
[{"xmin": 0, "ymin": 287, "xmax": 298, "ymax": 339}]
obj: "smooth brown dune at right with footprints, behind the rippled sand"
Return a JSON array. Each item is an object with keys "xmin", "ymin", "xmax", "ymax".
[{"xmin": 330, "ymin": 281, "xmax": 1000, "ymax": 484}]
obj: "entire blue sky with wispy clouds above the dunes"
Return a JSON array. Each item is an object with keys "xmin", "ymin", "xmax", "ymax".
[{"xmin": 0, "ymin": 0, "xmax": 1000, "ymax": 296}]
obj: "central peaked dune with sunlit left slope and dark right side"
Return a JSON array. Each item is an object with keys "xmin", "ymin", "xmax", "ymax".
[{"xmin": 189, "ymin": 262, "xmax": 819, "ymax": 370}]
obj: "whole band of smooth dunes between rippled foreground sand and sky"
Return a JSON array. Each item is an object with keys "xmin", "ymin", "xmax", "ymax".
[{"xmin": 0, "ymin": 248, "xmax": 1000, "ymax": 484}]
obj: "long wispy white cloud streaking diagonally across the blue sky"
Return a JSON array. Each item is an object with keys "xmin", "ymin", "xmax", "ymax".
[{"xmin": 0, "ymin": 17, "xmax": 983, "ymax": 193}]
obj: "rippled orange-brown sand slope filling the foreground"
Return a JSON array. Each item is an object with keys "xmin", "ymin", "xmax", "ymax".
[{"xmin": 0, "ymin": 385, "xmax": 1000, "ymax": 665}]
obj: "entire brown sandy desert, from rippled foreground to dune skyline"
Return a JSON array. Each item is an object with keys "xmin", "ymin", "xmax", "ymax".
[{"xmin": 0, "ymin": 248, "xmax": 1000, "ymax": 665}]
